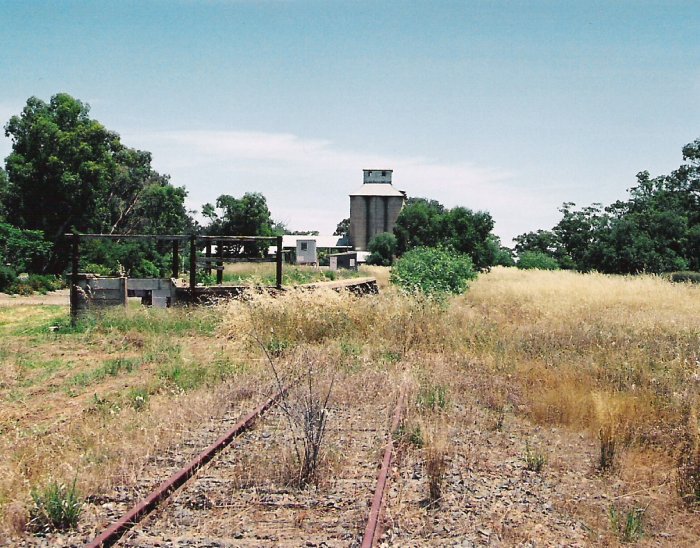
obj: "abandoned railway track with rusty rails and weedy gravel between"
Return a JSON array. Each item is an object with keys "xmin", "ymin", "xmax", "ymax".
[{"xmin": 88, "ymin": 378, "xmax": 402, "ymax": 547}]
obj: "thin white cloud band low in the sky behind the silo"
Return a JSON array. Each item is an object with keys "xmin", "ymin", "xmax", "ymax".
[{"xmin": 122, "ymin": 131, "xmax": 552, "ymax": 242}]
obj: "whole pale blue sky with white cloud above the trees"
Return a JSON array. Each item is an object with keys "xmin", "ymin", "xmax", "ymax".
[{"xmin": 0, "ymin": 0, "xmax": 700, "ymax": 244}]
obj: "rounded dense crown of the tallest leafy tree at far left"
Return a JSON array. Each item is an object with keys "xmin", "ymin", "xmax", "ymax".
[{"xmin": 5, "ymin": 93, "xmax": 121, "ymax": 241}]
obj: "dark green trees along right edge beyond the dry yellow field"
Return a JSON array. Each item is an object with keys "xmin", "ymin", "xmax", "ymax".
[{"xmin": 515, "ymin": 139, "xmax": 700, "ymax": 274}]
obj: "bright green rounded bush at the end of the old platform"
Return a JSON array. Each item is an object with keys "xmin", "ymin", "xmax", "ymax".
[{"xmin": 391, "ymin": 247, "xmax": 477, "ymax": 296}]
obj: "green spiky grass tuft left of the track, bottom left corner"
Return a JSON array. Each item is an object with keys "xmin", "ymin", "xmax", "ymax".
[{"xmin": 30, "ymin": 478, "xmax": 83, "ymax": 532}]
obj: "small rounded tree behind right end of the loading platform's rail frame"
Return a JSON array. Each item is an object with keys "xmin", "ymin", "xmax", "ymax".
[{"xmin": 202, "ymin": 192, "xmax": 276, "ymax": 256}]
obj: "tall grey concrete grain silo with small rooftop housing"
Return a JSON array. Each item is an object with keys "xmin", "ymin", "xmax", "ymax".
[{"xmin": 350, "ymin": 169, "xmax": 406, "ymax": 251}]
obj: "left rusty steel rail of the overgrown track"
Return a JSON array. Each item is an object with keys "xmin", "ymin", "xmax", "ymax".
[{"xmin": 86, "ymin": 386, "xmax": 288, "ymax": 548}]
